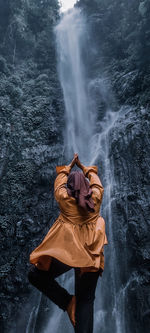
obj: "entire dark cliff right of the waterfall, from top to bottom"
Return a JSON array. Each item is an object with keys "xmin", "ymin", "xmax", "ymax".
[{"xmin": 77, "ymin": 0, "xmax": 150, "ymax": 333}]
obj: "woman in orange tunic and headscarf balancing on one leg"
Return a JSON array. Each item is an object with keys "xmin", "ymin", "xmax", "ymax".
[{"xmin": 28, "ymin": 154, "xmax": 108, "ymax": 333}]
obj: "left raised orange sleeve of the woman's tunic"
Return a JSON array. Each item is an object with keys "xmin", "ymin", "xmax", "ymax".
[{"xmin": 54, "ymin": 165, "xmax": 71, "ymax": 202}]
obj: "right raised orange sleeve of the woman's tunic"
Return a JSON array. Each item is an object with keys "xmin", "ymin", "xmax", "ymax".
[{"xmin": 83, "ymin": 165, "xmax": 104, "ymax": 202}]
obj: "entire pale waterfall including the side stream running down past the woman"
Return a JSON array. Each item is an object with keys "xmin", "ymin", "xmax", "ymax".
[{"xmin": 52, "ymin": 8, "xmax": 129, "ymax": 333}]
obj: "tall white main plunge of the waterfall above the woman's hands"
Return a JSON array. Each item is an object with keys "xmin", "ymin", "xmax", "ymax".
[{"xmin": 55, "ymin": 8, "xmax": 95, "ymax": 163}]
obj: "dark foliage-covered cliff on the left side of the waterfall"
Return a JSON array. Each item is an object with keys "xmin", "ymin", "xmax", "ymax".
[{"xmin": 0, "ymin": 0, "xmax": 64, "ymax": 332}]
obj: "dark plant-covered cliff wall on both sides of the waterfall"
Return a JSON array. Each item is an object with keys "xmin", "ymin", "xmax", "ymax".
[{"xmin": 0, "ymin": 0, "xmax": 150, "ymax": 333}]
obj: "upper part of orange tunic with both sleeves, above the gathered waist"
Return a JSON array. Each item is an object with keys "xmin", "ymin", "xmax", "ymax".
[{"xmin": 54, "ymin": 166, "xmax": 104, "ymax": 223}]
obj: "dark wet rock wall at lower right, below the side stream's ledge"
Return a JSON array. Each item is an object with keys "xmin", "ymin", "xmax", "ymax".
[{"xmin": 109, "ymin": 107, "xmax": 150, "ymax": 332}]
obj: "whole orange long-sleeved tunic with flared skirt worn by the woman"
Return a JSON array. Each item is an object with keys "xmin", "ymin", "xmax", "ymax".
[{"xmin": 30, "ymin": 166, "xmax": 108, "ymax": 272}]
